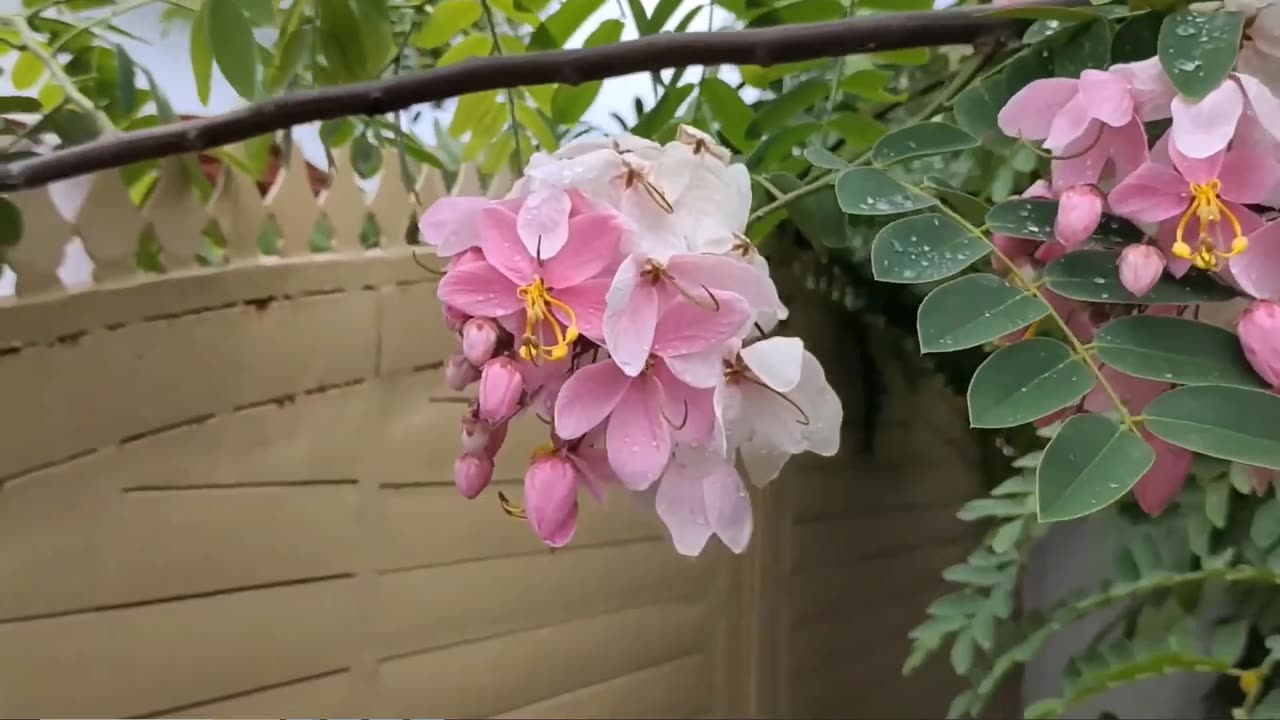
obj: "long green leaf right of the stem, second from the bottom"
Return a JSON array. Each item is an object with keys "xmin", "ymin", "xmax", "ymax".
[{"xmin": 1093, "ymin": 315, "xmax": 1263, "ymax": 387}]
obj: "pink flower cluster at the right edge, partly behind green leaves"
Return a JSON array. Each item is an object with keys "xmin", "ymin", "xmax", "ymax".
[{"xmin": 993, "ymin": 7, "xmax": 1280, "ymax": 514}]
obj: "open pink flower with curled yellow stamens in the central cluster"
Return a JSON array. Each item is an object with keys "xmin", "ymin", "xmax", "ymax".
[{"xmin": 438, "ymin": 197, "xmax": 622, "ymax": 360}]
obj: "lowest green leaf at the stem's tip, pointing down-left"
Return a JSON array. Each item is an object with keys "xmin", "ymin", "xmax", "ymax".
[{"xmin": 1036, "ymin": 414, "xmax": 1156, "ymax": 523}]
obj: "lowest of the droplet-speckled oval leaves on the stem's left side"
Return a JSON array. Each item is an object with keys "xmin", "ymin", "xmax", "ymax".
[{"xmin": 872, "ymin": 214, "xmax": 991, "ymax": 283}]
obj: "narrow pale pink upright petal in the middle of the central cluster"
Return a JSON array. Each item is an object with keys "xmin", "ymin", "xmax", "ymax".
[{"xmin": 604, "ymin": 255, "xmax": 658, "ymax": 377}]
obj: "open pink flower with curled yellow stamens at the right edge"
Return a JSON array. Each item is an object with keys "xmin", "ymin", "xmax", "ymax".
[{"xmin": 1108, "ymin": 136, "xmax": 1280, "ymax": 289}]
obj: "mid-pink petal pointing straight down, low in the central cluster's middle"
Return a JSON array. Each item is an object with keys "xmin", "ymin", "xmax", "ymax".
[{"xmin": 606, "ymin": 375, "xmax": 671, "ymax": 491}]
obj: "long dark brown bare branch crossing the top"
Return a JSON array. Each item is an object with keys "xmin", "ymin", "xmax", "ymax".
[{"xmin": 0, "ymin": 0, "xmax": 1089, "ymax": 192}]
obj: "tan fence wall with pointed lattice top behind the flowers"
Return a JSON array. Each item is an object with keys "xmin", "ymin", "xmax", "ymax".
[{"xmin": 0, "ymin": 148, "xmax": 998, "ymax": 717}]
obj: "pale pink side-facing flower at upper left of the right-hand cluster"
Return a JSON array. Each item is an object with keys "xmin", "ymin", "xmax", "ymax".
[{"xmin": 998, "ymin": 70, "xmax": 1147, "ymax": 190}]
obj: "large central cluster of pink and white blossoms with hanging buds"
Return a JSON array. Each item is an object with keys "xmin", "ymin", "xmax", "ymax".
[{"xmin": 420, "ymin": 128, "xmax": 842, "ymax": 555}]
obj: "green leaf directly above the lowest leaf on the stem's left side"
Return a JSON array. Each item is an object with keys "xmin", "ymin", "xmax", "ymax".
[{"xmin": 969, "ymin": 338, "xmax": 1094, "ymax": 428}]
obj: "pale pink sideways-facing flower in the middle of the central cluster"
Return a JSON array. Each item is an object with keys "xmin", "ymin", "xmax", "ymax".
[{"xmin": 604, "ymin": 255, "xmax": 785, "ymax": 376}]
